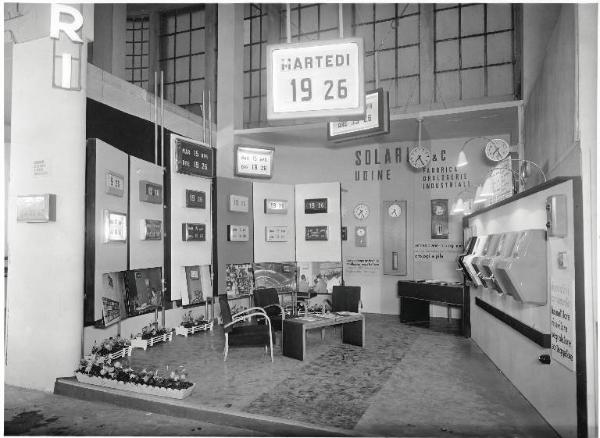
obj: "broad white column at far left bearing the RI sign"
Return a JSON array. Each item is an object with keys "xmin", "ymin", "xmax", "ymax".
[{"xmin": 5, "ymin": 5, "xmax": 93, "ymax": 391}]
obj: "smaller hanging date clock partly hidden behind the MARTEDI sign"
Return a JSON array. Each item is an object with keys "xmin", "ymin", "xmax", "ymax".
[{"xmin": 327, "ymin": 88, "xmax": 390, "ymax": 142}]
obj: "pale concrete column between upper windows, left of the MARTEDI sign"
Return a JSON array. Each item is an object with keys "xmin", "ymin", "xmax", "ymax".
[{"xmin": 217, "ymin": 3, "xmax": 244, "ymax": 177}]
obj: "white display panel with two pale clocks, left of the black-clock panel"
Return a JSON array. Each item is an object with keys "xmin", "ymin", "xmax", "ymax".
[{"xmin": 252, "ymin": 182, "xmax": 296, "ymax": 263}]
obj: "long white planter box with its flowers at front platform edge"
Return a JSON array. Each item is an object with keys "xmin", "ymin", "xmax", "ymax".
[{"xmin": 75, "ymin": 355, "xmax": 195, "ymax": 399}]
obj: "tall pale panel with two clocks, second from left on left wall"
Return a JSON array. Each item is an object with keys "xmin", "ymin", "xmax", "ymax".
[{"xmin": 129, "ymin": 157, "xmax": 165, "ymax": 269}]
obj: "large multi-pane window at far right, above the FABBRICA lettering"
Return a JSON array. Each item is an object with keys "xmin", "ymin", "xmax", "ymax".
[{"xmin": 434, "ymin": 3, "xmax": 515, "ymax": 103}]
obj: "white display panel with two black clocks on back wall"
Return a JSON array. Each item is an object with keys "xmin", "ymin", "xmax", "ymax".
[{"xmin": 295, "ymin": 182, "xmax": 342, "ymax": 262}]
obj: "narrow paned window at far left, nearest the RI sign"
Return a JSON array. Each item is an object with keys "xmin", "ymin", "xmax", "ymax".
[{"xmin": 125, "ymin": 17, "xmax": 150, "ymax": 90}]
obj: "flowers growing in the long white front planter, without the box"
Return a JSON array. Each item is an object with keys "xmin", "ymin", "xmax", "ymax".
[{"xmin": 75, "ymin": 354, "xmax": 194, "ymax": 390}]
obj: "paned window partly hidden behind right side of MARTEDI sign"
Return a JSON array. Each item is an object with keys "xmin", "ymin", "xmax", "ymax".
[{"xmin": 352, "ymin": 3, "xmax": 421, "ymax": 107}]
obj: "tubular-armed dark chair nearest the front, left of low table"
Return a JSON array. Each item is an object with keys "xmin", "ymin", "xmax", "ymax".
[{"xmin": 219, "ymin": 295, "xmax": 274, "ymax": 362}]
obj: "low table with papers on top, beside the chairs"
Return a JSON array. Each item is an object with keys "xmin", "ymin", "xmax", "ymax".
[{"xmin": 282, "ymin": 312, "xmax": 365, "ymax": 360}]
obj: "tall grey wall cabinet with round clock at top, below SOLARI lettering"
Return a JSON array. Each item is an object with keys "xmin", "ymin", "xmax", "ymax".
[{"xmin": 381, "ymin": 201, "xmax": 408, "ymax": 275}]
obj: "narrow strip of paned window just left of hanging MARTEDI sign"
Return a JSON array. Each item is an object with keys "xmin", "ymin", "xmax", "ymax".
[{"xmin": 244, "ymin": 4, "xmax": 267, "ymax": 128}]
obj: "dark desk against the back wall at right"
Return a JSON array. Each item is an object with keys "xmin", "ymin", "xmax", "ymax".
[{"xmin": 398, "ymin": 280, "xmax": 471, "ymax": 338}]
